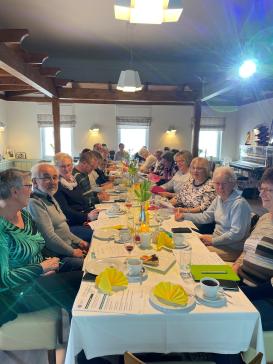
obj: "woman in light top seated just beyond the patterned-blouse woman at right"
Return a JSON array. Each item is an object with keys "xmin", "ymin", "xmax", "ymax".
[{"xmin": 157, "ymin": 150, "xmax": 192, "ymax": 198}]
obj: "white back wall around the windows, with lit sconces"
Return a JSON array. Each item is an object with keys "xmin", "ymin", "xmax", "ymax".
[{"xmin": 0, "ymin": 100, "xmax": 243, "ymax": 159}]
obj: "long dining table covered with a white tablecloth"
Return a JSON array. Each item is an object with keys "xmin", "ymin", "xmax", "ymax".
[{"xmin": 65, "ymin": 205, "xmax": 266, "ymax": 364}]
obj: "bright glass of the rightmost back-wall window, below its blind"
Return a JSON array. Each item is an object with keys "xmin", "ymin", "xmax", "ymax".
[{"xmin": 198, "ymin": 129, "xmax": 223, "ymax": 160}]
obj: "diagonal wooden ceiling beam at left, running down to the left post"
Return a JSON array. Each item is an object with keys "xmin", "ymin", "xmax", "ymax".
[{"xmin": 0, "ymin": 43, "xmax": 57, "ymax": 97}]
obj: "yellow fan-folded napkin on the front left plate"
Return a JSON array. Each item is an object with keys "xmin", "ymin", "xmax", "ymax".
[{"xmin": 96, "ymin": 267, "xmax": 128, "ymax": 294}]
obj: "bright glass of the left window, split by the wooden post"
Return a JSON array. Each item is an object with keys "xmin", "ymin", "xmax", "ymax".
[{"xmin": 40, "ymin": 127, "xmax": 73, "ymax": 159}]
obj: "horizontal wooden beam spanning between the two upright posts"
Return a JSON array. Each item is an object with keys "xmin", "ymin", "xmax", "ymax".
[{"xmin": 58, "ymin": 88, "xmax": 196, "ymax": 103}]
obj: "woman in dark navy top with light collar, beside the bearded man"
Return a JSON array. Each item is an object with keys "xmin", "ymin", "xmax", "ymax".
[{"xmin": 54, "ymin": 153, "xmax": 98, "ymax": 242}]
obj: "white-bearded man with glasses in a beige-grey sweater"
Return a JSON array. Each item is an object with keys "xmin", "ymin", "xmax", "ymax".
[{"xmin": 28, "ymin": 163, "xmax": 88, "ymax": 271}]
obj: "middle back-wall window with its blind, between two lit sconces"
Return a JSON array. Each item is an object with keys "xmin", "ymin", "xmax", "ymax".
[{"xmin": 117, "ymin": 117, "xmax": 151, "ymax": 155}]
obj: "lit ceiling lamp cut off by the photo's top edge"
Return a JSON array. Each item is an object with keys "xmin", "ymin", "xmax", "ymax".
[{"xmin": 114, "ymin": 0, "xmax": 183, "ymax": 24}]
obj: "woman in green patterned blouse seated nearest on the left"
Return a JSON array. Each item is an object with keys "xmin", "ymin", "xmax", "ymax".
[{"xmin": 0, "ymin": 169, "xmax": 82, "ymax": 326}]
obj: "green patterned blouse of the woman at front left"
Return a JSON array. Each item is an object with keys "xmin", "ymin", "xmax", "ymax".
[{"xmin": 0, "ymin": 210, "xmax": 45, "ymax": 292}]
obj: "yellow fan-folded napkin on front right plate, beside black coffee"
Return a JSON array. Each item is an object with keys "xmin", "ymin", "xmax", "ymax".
[{"xmin": 153, "ymin": 282, "xmax": 189, "ymax": 306}]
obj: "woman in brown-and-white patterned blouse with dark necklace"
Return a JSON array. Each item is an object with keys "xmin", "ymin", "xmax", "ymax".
[{"xmin": 170, "ymin": 157, "xmax": 216, "ymax": 213}]
